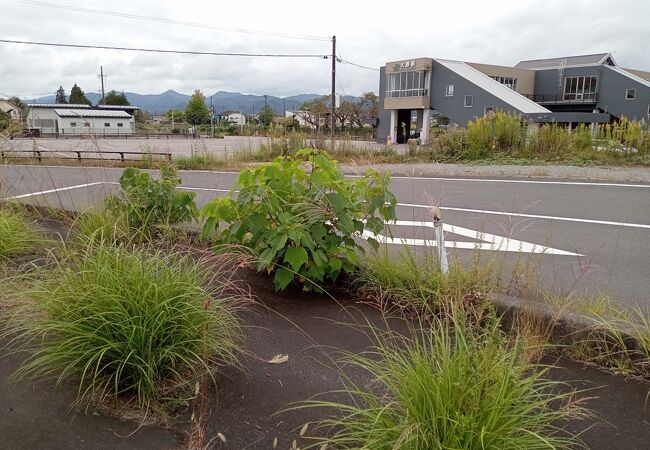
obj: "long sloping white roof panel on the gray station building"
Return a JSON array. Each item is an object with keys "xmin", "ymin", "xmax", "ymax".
[{"xmin": 434, "ymin": 59, "xmax": 551, "ymax": 114}]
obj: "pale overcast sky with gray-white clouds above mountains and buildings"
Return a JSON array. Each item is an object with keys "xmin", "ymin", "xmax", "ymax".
[{"xmin": 0, "ymin": 0, "xmax": 650, "ymax": 98}]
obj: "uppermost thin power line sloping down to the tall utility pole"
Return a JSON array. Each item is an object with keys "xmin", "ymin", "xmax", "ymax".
[{"xmin": 15, "ymin": 0, "xmax": 331, "ymax": 41}]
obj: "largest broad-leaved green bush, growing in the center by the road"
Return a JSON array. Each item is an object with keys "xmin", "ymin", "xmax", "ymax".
[{"xmin": 202, "ymin": 150, "xmax": 397, "ymax": 290}]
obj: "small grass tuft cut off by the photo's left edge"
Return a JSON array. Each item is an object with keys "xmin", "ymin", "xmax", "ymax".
[{"xmin": 0, "ymin": 205, "xmax": 42, "ymax": 260}]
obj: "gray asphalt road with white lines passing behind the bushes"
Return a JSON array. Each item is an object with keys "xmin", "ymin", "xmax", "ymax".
[{"xmin": 0, "ymin": 165, "xmax": 650, "ymax": 308}]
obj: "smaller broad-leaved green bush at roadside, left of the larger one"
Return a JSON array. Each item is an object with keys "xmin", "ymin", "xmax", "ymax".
[{"xmin": 106, "ymin": 166, "xmax": 197, "ymax": 231}]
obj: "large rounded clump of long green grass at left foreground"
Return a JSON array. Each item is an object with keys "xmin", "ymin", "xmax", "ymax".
[{"xmin": 5, "ymin": 245, "xmax": 239, "ymax": 408}]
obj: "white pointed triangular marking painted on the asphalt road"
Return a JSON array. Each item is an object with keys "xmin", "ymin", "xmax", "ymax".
[{"xmin": 363, "ymin": 220, "xmax": 583, "ymax": 256}]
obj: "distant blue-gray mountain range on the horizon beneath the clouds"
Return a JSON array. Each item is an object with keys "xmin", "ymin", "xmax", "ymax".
[{"xmin": 35, "ymin": 90, "xmax": 358, "ymax": 114}]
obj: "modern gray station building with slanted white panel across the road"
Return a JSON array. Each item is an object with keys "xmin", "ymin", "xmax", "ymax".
[{"xmin": 377, "ymin": 53, "xmax": 650, "ymax": 144}]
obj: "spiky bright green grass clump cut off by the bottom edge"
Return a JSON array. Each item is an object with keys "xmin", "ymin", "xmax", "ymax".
[{"xmin": 296, "ymin": 319, "xmax": 584, "ymax": 450}]
